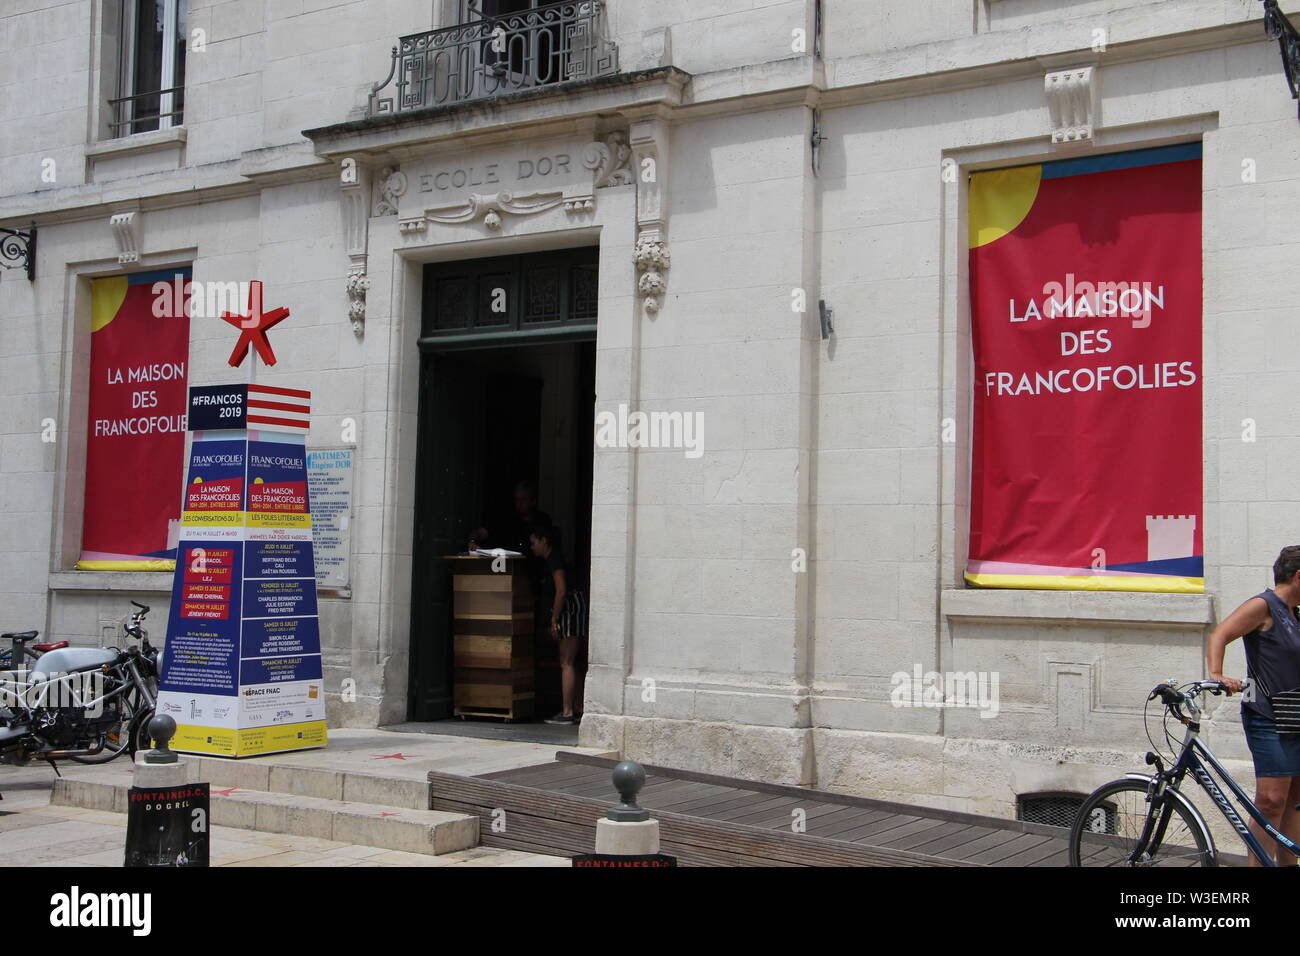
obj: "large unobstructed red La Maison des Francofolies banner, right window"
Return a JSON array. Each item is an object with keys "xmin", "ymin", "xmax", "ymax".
[{"xmin": 966, "ymin": 143, "xmax": 1205, "ymax": 593}]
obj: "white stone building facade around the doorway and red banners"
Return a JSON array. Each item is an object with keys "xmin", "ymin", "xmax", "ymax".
[{"xmin": 0, "ymin": 0, "xmax": 1300, "ymax": 832}]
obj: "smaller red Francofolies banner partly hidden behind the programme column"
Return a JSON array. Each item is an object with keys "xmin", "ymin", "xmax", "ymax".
[{"xmin": 77, "ymin": 269, "xmax": 190, "ymax": 571}]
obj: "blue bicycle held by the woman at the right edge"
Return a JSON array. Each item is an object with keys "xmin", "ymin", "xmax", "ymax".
[{"xmin": 1070, "ymin": 680, "xmax": 1300, "ymax": 866}]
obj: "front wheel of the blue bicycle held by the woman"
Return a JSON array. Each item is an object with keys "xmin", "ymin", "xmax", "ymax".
[{"xmin": 1070, "ymin": 779, "xmax": 1218, "ymax": 866}]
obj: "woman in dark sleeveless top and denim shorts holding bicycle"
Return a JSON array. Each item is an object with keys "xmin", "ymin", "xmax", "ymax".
[{"xmin": 1205, "ymin": 545, "xmax": 1300, "ymax": 866}]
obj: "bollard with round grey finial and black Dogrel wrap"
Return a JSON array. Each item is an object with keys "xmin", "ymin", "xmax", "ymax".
[{"xmin": 125, "ymin": 714, "xmax": 209, "ymax": 866}]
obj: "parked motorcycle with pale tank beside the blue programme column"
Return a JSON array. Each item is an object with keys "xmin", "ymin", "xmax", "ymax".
[{"xmin": 0, "ymin": 601, "xmax": 160, "ymax": 774}]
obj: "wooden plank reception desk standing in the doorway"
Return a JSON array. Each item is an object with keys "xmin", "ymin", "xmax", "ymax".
[{"xmin": 447, "ymin": 554, "xmax": 536, "ymax": 721}]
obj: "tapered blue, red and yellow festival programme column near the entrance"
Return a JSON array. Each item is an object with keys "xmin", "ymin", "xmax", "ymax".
[{"xmin": 159, "ymin": 386, "xmax": 326, "ymax": 757}]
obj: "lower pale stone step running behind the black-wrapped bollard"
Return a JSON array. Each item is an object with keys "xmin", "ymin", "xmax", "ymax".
[{"xmin": 49, "ymin": 766, "xmax": 478, "ymax": 855}]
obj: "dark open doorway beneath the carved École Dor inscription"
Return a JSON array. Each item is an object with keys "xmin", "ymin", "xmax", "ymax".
[{"xmin": 408, "ymin": 250, "xmax": 598, "ymax": 741}]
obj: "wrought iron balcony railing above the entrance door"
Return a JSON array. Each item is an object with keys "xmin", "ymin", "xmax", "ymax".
[{"xmin": 368, "ymin": 0, "xmax": 619, "ymax": 116}]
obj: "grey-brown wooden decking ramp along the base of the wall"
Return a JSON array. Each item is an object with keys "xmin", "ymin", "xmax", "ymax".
[{"xmin": 429, "ymin": 752, "xmax": 1081, "ymax": 866}]
